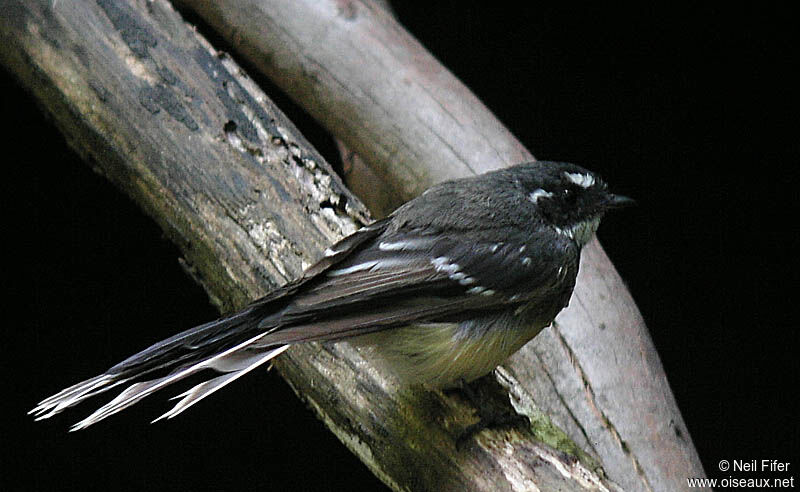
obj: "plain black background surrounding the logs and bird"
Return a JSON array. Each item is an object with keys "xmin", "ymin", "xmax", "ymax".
[{"xmin": 0, "ymin": 2, "xmax": 800, "ymax": 490}]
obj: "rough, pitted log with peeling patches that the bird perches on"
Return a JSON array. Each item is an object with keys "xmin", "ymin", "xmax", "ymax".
[{"xmin": 0, "ymin": 0, "xmax": 618, "ymax": 490}]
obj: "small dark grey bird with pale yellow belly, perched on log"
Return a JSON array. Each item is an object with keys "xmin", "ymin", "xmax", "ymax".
[{"xmin": 31, "ymin": 161, "xmax": 632, "ymax": 430}]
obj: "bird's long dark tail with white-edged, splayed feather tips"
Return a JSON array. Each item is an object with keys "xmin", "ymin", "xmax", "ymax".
[{"xmin": 29, "ymin": 307, "xmax": 289, "ymax": 431}]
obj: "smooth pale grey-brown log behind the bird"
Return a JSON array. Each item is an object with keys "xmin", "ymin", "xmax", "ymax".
[{"xmin": 172, "ymin": 0, "xmax": 703, "ymax": 491}]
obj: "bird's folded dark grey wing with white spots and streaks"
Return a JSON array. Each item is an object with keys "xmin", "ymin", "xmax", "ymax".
[{"xmin": 259, "ymin": 226, "xmax": 578, "ymax": 344}]
